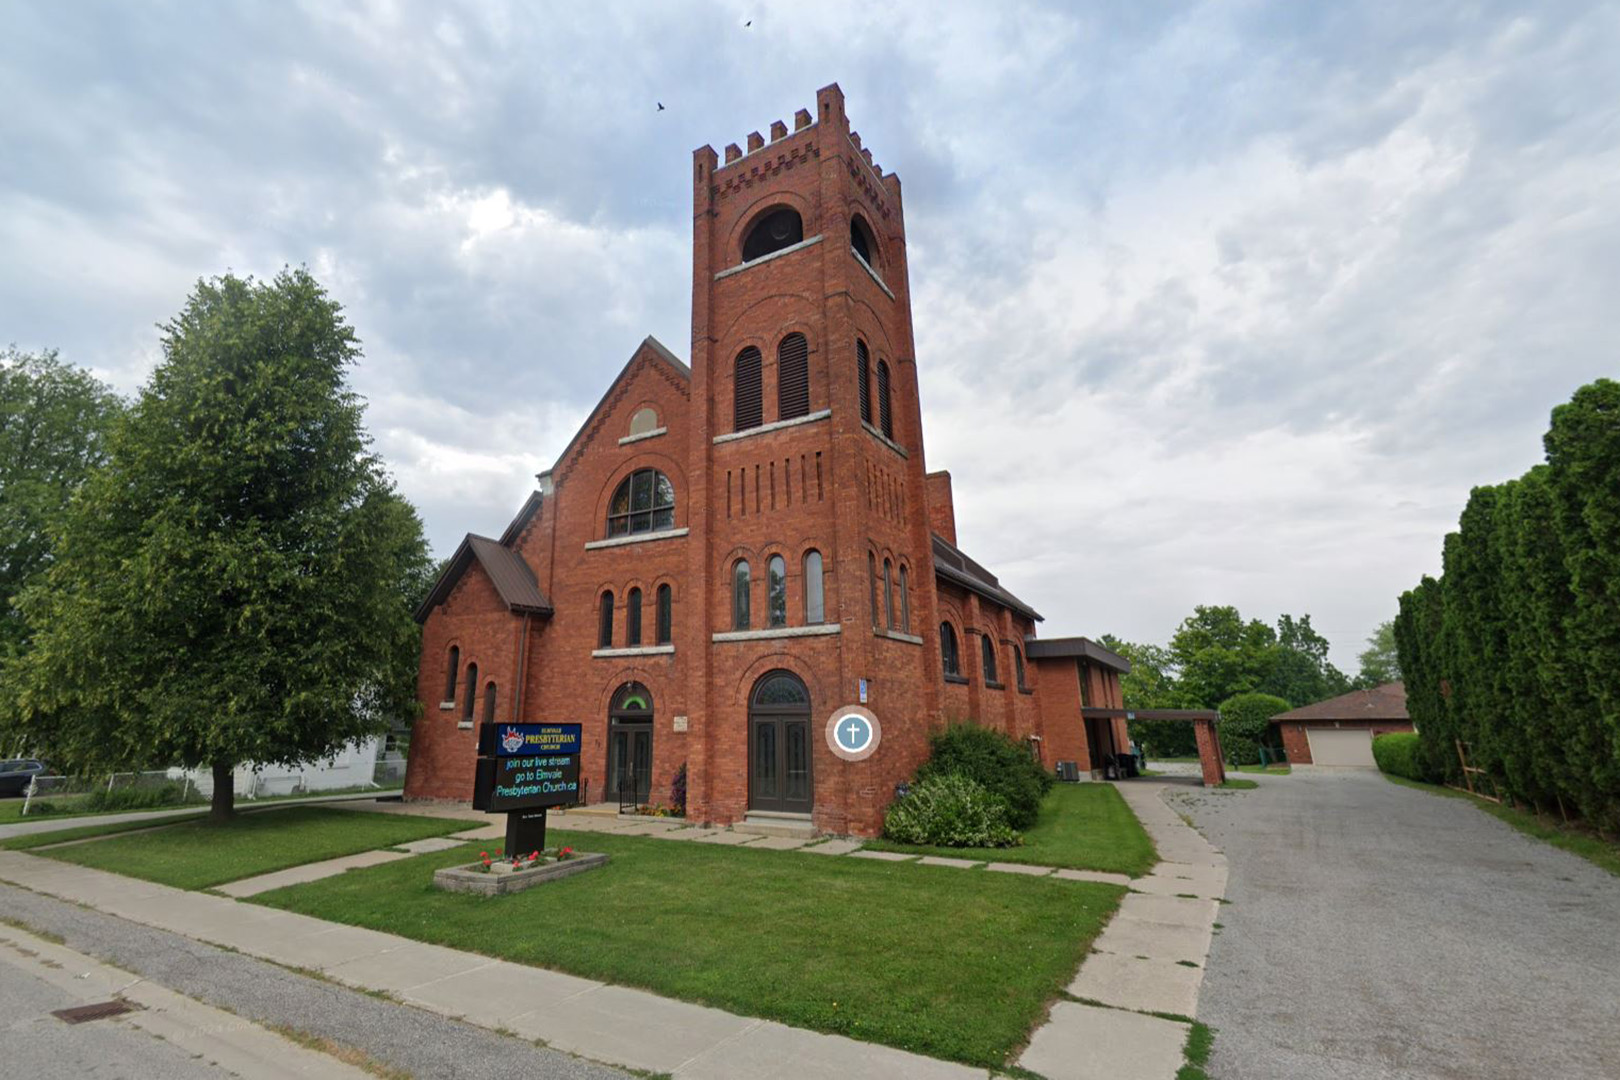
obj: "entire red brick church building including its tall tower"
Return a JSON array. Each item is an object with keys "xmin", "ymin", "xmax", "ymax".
[{"xmin": 405, "ymin": 86, "xmax": 1128, "ymax": 834}]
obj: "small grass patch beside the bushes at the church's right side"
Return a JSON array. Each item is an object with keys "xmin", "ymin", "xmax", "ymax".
[{"xmin": 867, "ymin": 784, "xmax": 1158, "ymax": 878}]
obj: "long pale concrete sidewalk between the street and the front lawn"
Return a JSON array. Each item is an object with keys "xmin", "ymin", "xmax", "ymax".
[{"xmin": 0, "ymin": 852, "xmax": 988, "ymax": 1080}]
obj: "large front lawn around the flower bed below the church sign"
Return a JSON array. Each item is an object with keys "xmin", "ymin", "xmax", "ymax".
[{"xmin": 253, "ymin": 831, "xmax": 1124, "ymax": 1067}]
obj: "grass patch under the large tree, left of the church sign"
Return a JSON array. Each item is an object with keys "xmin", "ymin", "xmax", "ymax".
[{"xmin": 37, "ymin": 806, "xmax": 473, "ymax": 889}]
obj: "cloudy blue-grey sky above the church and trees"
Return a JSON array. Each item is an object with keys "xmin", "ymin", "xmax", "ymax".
[{"xmin": 0, "ymin": 0, "xmax": 1620, "ymax": 672}]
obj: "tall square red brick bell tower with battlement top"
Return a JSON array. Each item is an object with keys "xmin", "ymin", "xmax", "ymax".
[{"xmin": 682, "ymin": 84, "xmax": 941, "ymax": 832}]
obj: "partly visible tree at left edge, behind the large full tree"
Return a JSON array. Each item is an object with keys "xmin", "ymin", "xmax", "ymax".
[{"xmin": 0, "ymin": 348, "xmax": 120, "ymax": 664}]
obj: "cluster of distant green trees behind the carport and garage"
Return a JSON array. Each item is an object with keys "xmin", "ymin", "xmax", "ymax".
[{"xmin": 1102, "ymin": 606, "xmax": 1400, "ymax": 761}]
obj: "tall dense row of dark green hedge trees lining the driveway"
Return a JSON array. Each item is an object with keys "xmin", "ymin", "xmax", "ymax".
[{"xmin": 1395, "ymin": 379, "xmax": 1620, "ymax": 831}]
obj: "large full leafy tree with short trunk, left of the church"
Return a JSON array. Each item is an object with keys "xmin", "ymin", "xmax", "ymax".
[{"xmin": 10, "ymin": 270, "xmax": 428, "ymax": 821}]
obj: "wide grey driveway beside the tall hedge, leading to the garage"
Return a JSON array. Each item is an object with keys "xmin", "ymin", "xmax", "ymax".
[{"xmin": 1173, "ymin": 771, "xmax": 1620, "ymax": 1080}]
